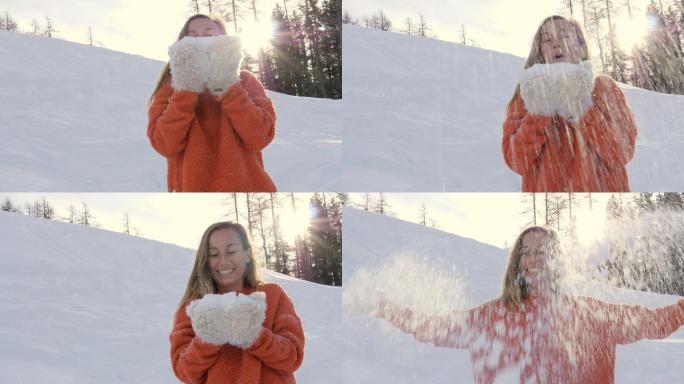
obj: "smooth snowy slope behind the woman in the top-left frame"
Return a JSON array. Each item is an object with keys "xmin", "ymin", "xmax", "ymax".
[{"xmin": 0, "ymin": 31, "xmax": 342, "ymax": 191}]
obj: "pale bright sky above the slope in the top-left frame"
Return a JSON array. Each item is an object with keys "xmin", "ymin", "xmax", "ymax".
[{"xmin": 0, "ymin": 0, "xmax": 275, "ymax": 61}]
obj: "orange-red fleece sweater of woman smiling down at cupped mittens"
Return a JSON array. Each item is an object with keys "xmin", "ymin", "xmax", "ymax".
[{"xmin": 170, "ymin": 284, "xmax": 304, "ymax": 384}]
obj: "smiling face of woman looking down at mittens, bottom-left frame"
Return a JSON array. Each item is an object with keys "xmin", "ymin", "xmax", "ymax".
[{"xmin": 207, "ymin": 228, "xmax": 250, "ymax": 293}]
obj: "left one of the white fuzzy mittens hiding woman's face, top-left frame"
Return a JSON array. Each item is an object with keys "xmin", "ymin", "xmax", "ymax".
[{"xmin": 169, "ymin": 36, "xmax": 209, "ymax": 93}]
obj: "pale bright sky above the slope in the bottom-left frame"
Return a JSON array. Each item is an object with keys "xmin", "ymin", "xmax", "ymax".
[{"xmin": 0, "ymin": 193, "xmax": 311, "ymax": 249}]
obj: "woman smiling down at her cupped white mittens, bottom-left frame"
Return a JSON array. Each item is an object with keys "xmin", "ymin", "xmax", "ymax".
[{"xmin": 170, "ymin": 222, "xmax": 304, "ymax": 384}]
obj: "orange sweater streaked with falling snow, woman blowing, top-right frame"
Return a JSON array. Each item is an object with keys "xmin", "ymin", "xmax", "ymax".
[{"xmin": 502, "ymin": 76, "xmax": 637, "ymax": 192}]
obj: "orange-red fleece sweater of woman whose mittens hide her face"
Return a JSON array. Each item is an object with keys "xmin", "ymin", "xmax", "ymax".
[{"xmin": 147, "ymin": 71, "xmax": 276, "ymax": 192}]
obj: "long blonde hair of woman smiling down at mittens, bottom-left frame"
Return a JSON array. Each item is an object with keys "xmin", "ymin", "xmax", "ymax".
[{"xmin": 179, "ymin": 221, "xmax": 262, "ymax": 307}]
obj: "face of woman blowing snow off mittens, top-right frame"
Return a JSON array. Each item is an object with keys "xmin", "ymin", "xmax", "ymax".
[{"xmin": 541, "ymin": 20, "xmax": 584, "ymax": 64}]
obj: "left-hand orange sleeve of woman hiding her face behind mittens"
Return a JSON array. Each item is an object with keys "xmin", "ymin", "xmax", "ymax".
[{"xmin": 147, "ymin": 80, "xmax": 199, "ymax": 157}]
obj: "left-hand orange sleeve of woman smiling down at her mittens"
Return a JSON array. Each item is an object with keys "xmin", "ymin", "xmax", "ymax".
[{"xmin": 170, "ymin": 306, "xmax": 221, "ymax": 384}]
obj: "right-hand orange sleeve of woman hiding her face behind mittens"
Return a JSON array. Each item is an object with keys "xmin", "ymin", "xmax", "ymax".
[{"xmin": 221, "ymin": 71, "xmax": 275, "ymax": 151}]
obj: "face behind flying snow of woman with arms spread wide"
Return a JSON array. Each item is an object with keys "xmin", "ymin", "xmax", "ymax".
[{"xmin": 520, "ymin": 231, "xmax": 552, "ymax": 291}]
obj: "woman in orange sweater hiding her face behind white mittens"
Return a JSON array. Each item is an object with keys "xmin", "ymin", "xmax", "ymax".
[{"xmin": 147, "ymin": 15, "xmax": 276, "ymax": 192}]
